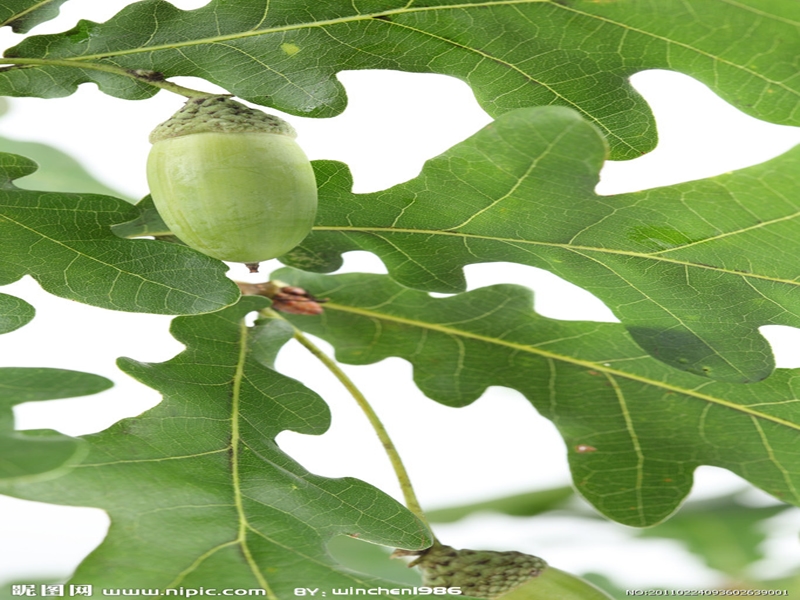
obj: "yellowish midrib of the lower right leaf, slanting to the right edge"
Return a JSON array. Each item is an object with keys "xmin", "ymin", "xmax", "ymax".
[{"xmin": 325, "ymin": 302, "xmax": 800, "ymax": 431}]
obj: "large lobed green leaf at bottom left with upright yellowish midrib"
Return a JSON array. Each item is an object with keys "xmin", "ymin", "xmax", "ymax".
[{"xmin": 0, "ymin": 297, "xmax": 432, "ymax": 598}]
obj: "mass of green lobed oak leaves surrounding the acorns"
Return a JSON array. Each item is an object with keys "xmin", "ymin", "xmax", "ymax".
[{"xmin": 0, "ymin": 0, "xmax": 800, "ymax": 598}]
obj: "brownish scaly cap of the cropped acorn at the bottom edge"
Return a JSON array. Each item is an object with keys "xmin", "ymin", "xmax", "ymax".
[{"xmin": 409, "ymin": 544, "xmax": 547, "ymax": 598}]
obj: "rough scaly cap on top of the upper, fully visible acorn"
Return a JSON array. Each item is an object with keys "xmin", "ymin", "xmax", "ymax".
[{"xmin": 150, "ymin": 96, "xmax": 297, "ymax": 144}]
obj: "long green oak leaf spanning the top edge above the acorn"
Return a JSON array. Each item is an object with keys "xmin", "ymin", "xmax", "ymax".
[{"xmin": 0, "ymin": 0, "xmax": 800, "ymax": 159}]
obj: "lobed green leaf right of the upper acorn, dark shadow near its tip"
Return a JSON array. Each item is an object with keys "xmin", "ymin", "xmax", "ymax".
[{"xmin": 282, "ymin": 107, "xmax": 800, "ymax": 382}]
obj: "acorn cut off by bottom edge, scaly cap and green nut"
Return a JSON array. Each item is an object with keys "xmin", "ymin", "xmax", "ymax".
[{"xmin": 406, "ymin": 544, "xmax": 611, "ymax": 600}]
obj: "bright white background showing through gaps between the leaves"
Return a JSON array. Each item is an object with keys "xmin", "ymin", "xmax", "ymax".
[{"xmin": 0, "ymin": 0, "xmax": 800, "ymax": 588}]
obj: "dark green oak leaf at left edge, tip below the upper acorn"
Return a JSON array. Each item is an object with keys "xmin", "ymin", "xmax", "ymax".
[{"xmin": 0, "ymin": 154, "xmax": 239, "ymax": 314}]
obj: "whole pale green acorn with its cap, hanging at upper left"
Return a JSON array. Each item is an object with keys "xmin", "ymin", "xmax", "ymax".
[{"xmin": 147, "ymin": 96, "xmax": 317, "ymax": 264}]
